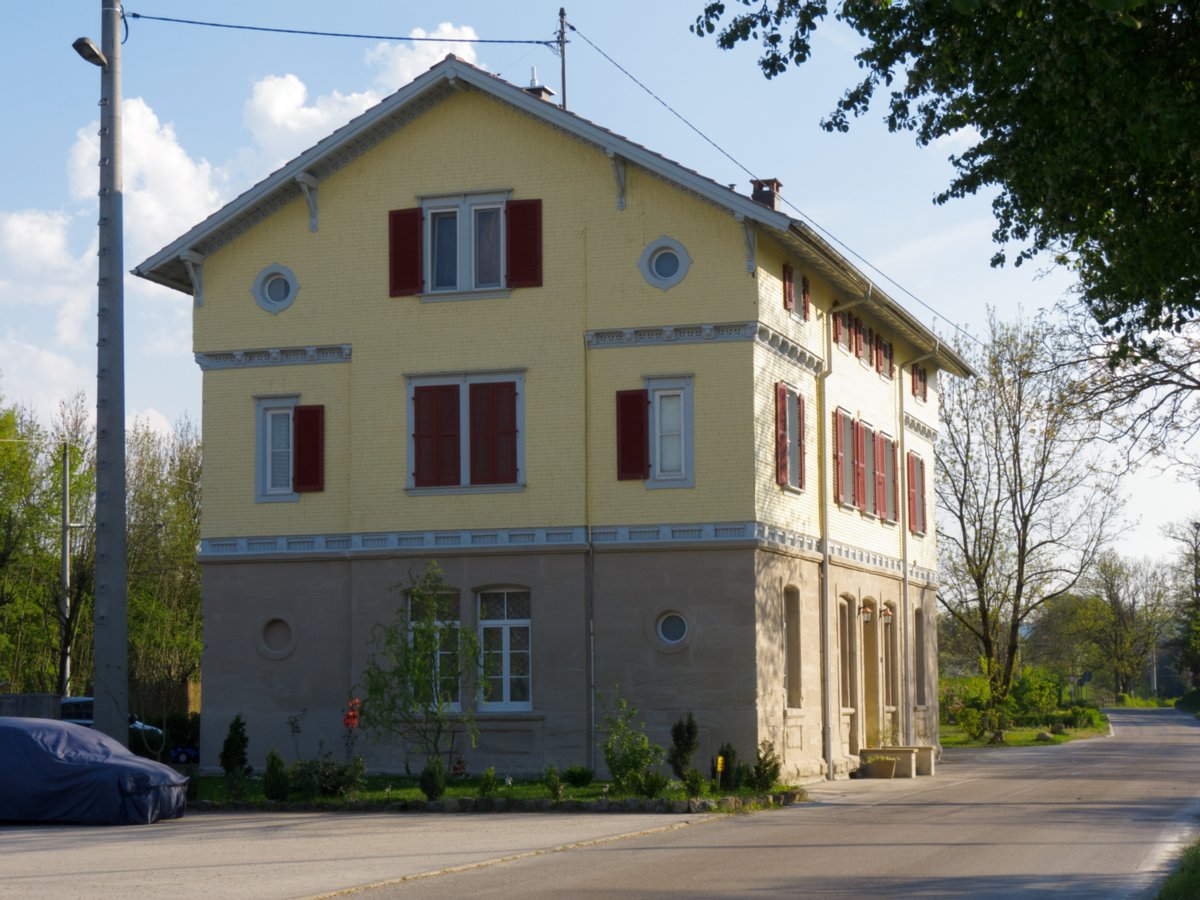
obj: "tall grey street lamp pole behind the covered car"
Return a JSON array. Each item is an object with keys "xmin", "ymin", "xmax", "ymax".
[{"xmin": 72, "ymin": 0, "xmax": 130, "ymax": 744}]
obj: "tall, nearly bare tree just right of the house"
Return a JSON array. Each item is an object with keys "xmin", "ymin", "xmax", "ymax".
[{"xmin": 936, "ymin": 316, "xmax": 1117, "ymax": 704}]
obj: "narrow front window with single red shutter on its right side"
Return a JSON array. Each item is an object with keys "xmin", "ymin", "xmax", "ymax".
[{"xmin": 254, "ymin": 396, "xmax": 325, "ymax": 503}]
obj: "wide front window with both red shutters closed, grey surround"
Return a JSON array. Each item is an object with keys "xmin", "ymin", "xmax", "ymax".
[{"xmin": 408, "ymin": 374, "xmax": 524, "ymax": 490}]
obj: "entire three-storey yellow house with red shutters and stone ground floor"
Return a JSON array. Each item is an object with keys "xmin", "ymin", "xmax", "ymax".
[{"xmin": 137, "ymin": 56, "xmax": 970, "ymax": 780}]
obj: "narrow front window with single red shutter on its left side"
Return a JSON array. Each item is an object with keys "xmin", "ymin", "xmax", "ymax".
[{"xmin": 617, "ymin": 376, "xmax": 695, "ymax": 487}]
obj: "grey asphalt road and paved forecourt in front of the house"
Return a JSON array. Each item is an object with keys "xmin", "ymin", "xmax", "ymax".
[{"xmin": 0, "ymin": 710, "xmax": 1200, "ymax": 900}]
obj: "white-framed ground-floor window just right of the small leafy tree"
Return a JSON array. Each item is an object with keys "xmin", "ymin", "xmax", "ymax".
[{"xmin": 479, "ymin": 590, "xmax": 533, "ymax": 710}]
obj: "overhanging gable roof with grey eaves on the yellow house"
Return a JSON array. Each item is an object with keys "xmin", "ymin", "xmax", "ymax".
[{"xmin": 133, "ymin": 55, "xmax": 974, "ymax": 377}]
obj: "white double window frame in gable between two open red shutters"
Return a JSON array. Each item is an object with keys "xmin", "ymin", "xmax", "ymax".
[{"xmin": 421, "ymin": 191, "xmax": 511, "ymax": 300}]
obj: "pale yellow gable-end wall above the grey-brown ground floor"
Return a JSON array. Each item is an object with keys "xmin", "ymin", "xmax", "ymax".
[{"xmin": 194, "ymin": 91, "xmax": 757, "ymax": 536}]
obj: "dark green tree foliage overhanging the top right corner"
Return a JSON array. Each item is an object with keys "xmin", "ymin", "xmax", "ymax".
[{"xmin": 691, "ymin": 0, "xmax": 1200, "ymax": 358}]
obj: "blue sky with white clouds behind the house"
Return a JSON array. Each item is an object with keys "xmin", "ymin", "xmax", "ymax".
[{"xmin": 0, "ymin": 0, "xmax": 1200, "ymax": 553}]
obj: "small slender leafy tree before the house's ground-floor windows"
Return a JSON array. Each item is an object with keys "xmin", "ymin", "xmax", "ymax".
[{"xmin": 360, "ymin": 562, "xmax": 479, "ymax": 774}]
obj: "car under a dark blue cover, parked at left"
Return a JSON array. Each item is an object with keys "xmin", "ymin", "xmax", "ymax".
[{"xmin": 0, "ymin": 716, "xmax": 187, "ymax": 824}]
